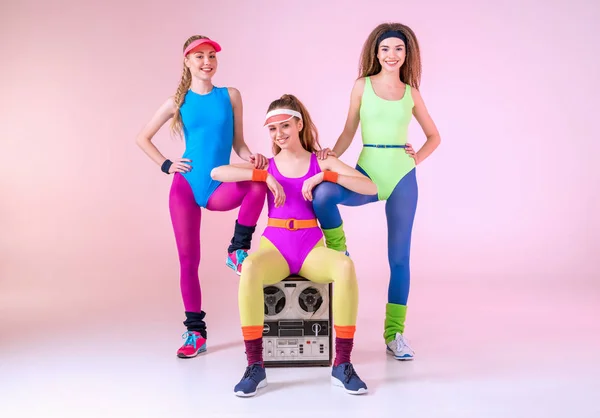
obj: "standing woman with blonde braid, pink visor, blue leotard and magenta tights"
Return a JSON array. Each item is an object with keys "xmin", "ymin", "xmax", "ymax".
[{"xmin": 137, "ymin": 35, "xmax": 267, "ymax": 358}]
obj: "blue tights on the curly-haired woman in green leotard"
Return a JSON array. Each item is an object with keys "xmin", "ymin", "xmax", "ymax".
[{"xmin": 313, "ymin": 166, "xmax": 418, "ymax": 305}]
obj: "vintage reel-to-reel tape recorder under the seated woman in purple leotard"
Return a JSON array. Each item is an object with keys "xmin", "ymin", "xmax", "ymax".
[{"xmin": 263, "ymin": 276, "xmax": 333, "ymax": 367}]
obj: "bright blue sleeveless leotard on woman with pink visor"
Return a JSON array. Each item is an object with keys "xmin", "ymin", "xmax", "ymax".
[{"xmin": 180, "ymin": 86, "xmax": 233, "ymax": 208}]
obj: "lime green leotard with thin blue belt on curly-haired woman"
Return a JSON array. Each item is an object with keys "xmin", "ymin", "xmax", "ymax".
[{"xmin": 358, "ymin": 77, "xmax": 415, "ymax": 200}]
